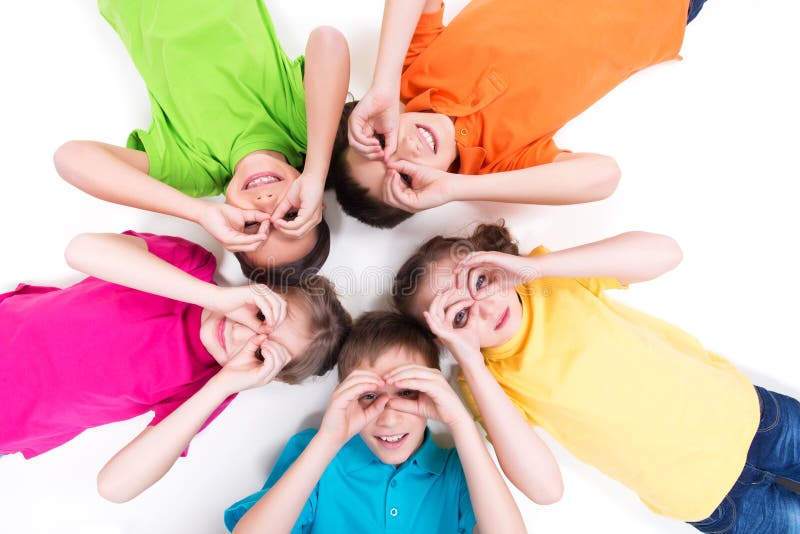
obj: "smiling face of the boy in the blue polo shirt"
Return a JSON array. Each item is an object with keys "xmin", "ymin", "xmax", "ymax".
[{"xmin": 355, "ymin": 347, "xmax": 428, "ymax": 465}]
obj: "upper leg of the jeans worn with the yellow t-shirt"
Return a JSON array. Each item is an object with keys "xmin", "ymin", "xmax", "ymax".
[{"xmin": 747, "ymin": 387, "xmax": 800, "ymax": 482}]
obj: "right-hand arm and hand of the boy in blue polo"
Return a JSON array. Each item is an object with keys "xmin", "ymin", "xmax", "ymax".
[{"xmin": 386, "ymin": 365, "xmax": 538, "ymax": 534}]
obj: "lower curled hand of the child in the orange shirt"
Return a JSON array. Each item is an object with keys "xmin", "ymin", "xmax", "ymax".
[{"xmin": 382, "ymin": 160, "xmax": 452, "ymax": 213}]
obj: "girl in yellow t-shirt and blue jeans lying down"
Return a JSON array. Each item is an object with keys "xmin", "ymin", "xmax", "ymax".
[{"xmin": 394, "ymin": 221, "xmax": 800, "ymax": 532}]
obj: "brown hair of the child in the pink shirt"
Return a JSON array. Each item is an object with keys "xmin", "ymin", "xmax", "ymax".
[{"xmin": 277, "ymin": 275, "xmax": 353, "ymax": 384}]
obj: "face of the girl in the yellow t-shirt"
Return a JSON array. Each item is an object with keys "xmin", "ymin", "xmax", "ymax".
[{"xmin": 413, "ymin": 258, "xmax": 522, "ymax": 349}]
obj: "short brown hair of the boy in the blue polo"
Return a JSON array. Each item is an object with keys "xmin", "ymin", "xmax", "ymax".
[{"xmin": 337, "ymin": 311, "xmax": 439, "ymax": 382}]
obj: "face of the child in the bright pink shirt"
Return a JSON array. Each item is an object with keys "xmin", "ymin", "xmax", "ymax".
[{"xmin": 200, "ymin": 295, "xmax": 311, "ymax": 365}]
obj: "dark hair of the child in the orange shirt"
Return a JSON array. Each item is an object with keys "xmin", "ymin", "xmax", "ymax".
[{"xmin": 325, "ymin": 100, "xmax": 413, "ymax": 228}]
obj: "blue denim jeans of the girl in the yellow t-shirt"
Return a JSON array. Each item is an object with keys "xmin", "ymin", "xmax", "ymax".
[{"xmin": 689, "ymin": 387, "xmax": 800, "ymax": 534}]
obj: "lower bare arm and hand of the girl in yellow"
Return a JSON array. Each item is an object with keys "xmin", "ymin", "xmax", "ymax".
[{"xmin": 424, "ymin": 296, "xmax": 564, "ymax": 504}]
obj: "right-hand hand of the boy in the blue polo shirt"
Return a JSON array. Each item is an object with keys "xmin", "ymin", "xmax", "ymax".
[{"xmin": 383, "ymin": 365, "xmax": 472, "ymax": 428}]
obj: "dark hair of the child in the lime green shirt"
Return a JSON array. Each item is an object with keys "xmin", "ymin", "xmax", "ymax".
[{"xmin": 234, "ymin": 217, "xmax": 331, "ymax": 287}]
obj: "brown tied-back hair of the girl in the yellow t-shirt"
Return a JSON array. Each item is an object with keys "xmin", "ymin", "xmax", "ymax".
[{"xmin": 392, "ymin": 219, "xmax": 519, "ymax": 322}]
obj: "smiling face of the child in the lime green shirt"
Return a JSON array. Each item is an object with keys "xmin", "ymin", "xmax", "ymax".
[{"xmin": 225, "ymin": 150, "xmax": 318, "ymax": 267}]
